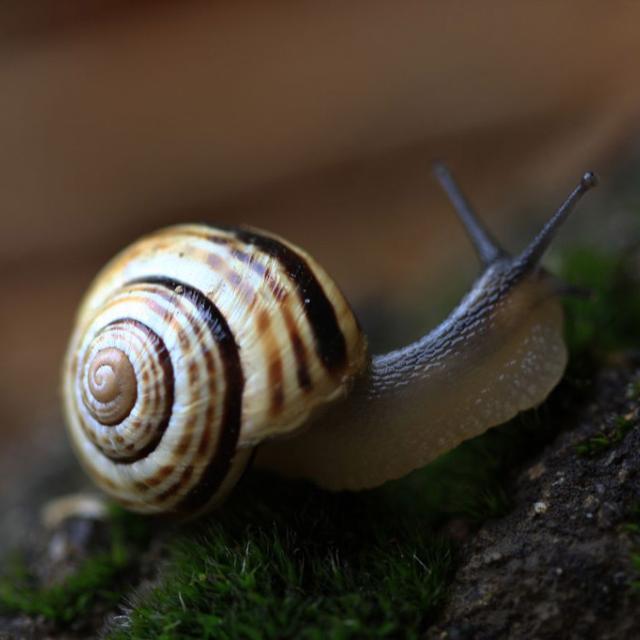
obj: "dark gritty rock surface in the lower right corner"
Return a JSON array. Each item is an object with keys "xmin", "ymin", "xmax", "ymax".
[{"xmin": 429, "ymin": 366, "xmax": 640, "ymax": 640}]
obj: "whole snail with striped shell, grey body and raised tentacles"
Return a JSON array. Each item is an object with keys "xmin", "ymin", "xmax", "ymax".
[{"xmin": 63, "ymin": 165, "xmax": 596, "ymax": 515}]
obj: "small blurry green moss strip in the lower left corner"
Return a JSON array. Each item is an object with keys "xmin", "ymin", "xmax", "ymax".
[{"xmin": 0, "ymin": 509, "xmax": 148, "ymax": 626}]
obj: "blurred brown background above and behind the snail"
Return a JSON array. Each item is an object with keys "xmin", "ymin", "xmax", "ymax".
[{"xmin": 0, "ymin": 0, "xmax": 640, "ymax": 481}]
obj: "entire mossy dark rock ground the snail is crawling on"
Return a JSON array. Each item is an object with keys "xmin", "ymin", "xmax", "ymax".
[{"xmin": 0, "ymin": 168, "xmax": 640, "ymax": 639}]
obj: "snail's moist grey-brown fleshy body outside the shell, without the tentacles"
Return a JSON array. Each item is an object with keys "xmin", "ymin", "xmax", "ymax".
[{"xmin": 256, "ymin": 265, "xmax": 567, "ymax": 490}]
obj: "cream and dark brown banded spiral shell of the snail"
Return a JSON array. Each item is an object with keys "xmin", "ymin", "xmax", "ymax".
[{"xmin": 64, "ymin": 225, "xmax": 368, "ymax": 514}]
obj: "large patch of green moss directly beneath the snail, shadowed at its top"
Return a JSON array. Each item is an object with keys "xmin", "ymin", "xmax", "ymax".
[{"xmin": 112, "ymin": 437, "xmax": 524, "ymax": 640}]
